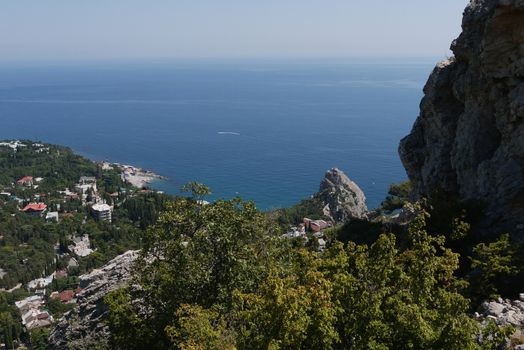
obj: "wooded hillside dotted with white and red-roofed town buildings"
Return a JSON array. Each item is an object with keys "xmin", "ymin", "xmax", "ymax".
[{"xmin": 0, "ymin": 141, "xmax": 169, "ymax": 345}]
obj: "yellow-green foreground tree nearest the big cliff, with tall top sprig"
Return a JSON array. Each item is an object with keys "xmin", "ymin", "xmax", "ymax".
[{"xmin": 330, "ymin": 214, "xmax": 476, "ymax": 349}]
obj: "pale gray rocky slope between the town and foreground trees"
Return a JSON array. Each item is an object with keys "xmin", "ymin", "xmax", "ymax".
[{"xmin": 49, "ymin": 251, "xmax": 138, "ymax": 350}]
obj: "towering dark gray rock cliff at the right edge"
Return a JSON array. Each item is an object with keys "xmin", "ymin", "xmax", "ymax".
[{"xmin": 399, "ymin": 0, "xmax": 524, "ymax": 237}]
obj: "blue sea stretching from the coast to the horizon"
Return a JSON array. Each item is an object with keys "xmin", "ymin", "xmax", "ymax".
[{"xmin": 0, "ymin": 60, "xmax": 433, "ymax": 209}]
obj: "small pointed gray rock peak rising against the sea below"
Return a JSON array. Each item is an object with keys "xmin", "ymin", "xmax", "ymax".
[{"xmin": 318, "ymin": 168, "xmax": 368, "ymax": 223}]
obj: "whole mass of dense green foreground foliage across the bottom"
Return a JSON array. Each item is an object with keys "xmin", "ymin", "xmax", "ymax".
[{"xmin": 106, "ymin": 188, "xmax": 488, "ymax": 349}]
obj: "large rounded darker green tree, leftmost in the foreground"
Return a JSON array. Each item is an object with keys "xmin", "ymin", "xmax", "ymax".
[{"xmin": 105, "ymin": 191, "xmax": 276, "ymax": 349}]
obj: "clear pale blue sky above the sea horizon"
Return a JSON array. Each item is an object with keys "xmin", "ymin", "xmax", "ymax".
[{"xmin": 0, "ymin": 0, "xmax": 468, "ymax": 62}]
